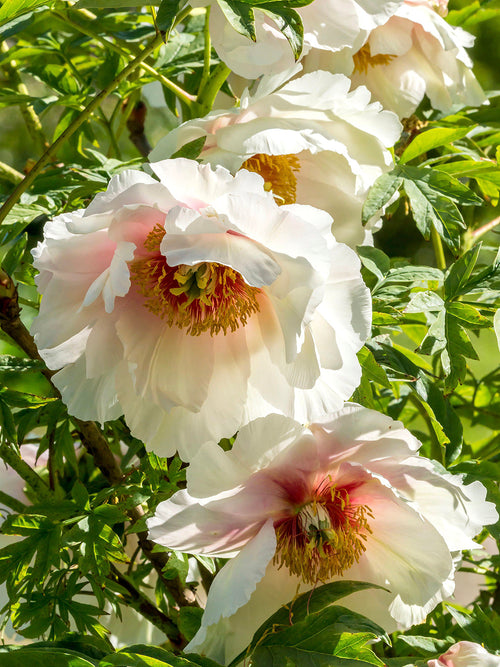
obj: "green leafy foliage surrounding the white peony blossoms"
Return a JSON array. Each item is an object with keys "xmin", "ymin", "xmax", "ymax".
[{"xmin": 0, "ymin": 0, "xmax": 500, "ymax": 667}]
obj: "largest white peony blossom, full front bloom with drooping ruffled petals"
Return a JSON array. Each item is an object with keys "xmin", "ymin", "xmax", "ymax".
[{"xmin": 32, "ymin": 158, "xmax": 371, "ymax": 460}]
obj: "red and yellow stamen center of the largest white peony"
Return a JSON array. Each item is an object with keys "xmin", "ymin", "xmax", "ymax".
[{"xmin": 130, "ymin": 225, "xmax": 260, "ymax": 336}]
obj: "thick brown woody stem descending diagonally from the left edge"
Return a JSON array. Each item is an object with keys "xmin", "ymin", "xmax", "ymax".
[{"xmin": 0, "ymin": 269, "xmax": 197, "ymax": 607}]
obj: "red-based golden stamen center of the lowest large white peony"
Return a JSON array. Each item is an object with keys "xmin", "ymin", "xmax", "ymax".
[{"xmin": 274, "ymin": 485, "xmax": 373, "ymax": 585}]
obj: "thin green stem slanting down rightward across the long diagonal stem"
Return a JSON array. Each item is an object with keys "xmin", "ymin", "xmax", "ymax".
[{"xmin": 52, "ymin": 8, "xmax": 196, "ymax": 106}]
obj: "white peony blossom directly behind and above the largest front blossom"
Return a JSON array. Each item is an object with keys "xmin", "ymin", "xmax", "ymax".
[{"xmin": 151, "ymin": 72, "xmax": 401, "ymax": 246}]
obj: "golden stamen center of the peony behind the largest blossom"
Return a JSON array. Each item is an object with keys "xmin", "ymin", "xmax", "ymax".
[{"xmin": 241, "ymin": 153, "xmax": 300, "ymax": 206}]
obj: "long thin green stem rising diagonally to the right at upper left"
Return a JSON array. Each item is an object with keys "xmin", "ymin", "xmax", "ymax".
[{"xmin": 0, "ymin": 35, "xmax": 163, "ymax": 224}]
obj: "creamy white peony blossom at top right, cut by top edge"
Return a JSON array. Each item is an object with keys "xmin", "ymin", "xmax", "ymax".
[{"xmin": 306, "ymin": 0, "xmax": 485, "ymax": 118}]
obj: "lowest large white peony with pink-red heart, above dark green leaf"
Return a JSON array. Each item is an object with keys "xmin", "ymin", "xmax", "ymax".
[{"xmin": 148, "ymin": 404, "xmax": 498, "ymax": 664}]
